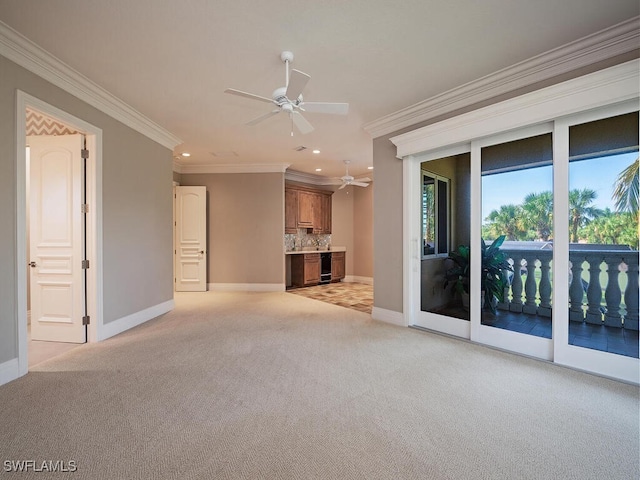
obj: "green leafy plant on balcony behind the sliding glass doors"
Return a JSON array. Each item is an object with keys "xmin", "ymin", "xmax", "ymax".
[{"xmin": 444, "ymin": 235, "xmax": 513, "ymax": 313}]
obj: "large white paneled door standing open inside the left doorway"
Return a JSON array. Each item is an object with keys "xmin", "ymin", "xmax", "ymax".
[{"xmin": 27, "ymin": 135, "xmax": 86, "ymax": 343}]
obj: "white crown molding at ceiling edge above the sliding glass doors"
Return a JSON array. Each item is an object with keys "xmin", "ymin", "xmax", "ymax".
[{"xmin": 363, "ymin": 17, "xmax": 640, "ymax": 138}]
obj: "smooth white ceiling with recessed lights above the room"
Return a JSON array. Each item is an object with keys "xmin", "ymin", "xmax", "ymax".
[{"xmin": 0, "ymin": 0, "xmax": 640, "ymax": 176}]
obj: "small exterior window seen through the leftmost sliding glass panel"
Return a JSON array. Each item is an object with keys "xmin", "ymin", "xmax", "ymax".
[{"xmin": 422, "ymin": 170, "xmax": 449, "ymax": 258}]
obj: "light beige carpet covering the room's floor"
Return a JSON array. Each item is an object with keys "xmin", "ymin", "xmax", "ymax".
[{"xmin": 0, "ymin": 292, "xmax": 640, "ymax": 480}]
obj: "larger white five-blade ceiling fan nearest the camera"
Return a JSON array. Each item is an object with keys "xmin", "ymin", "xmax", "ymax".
[{"xmin": 224, "ymin": 51, "xmax": 349, "ymax": 136}]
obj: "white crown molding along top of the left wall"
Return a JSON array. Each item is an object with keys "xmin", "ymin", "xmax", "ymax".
[{"xmin": 0, "ymin": 21, "xmax": 182, "ymax": 150}]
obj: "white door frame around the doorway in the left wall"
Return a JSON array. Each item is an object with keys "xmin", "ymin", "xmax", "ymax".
[{"xmin": 15, "ymin": 90, "xmax": 103, "ymax": 376}]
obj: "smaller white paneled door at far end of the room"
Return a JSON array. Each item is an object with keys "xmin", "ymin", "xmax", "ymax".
[{"xmin": 174, "ymin": 186, "xmax": 207, "ymax": 292}]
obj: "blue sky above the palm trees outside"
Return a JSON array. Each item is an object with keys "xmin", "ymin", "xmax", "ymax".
[{"xmin": 482, "ymin": 152, "xmax": 638, "ymax": 221}]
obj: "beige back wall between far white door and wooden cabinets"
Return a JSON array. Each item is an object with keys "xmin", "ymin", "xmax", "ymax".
[{"xmin": 180, "ymin": 173, "xmax": 285, "ymax": 285}]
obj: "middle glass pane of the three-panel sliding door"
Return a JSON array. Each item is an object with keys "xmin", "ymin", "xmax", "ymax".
[{"xmin": 480, "ymin": 133, "xmax": 554, "ymax": 338}]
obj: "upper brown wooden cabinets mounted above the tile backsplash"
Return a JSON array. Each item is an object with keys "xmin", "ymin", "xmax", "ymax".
[{"xmin": 284, "ymin": 185, "xmax": 333, "ymax": 234}]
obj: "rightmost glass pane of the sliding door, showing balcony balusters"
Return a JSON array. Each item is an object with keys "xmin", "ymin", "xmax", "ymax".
[{"xmin": 568, "ymin": 112, "xmax": 639, "ymax": 358}]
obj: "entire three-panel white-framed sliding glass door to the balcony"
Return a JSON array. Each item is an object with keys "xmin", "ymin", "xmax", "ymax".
[{"xmin": 405, "ymin": 103, "xmax": 640, "ymax": 381}]
